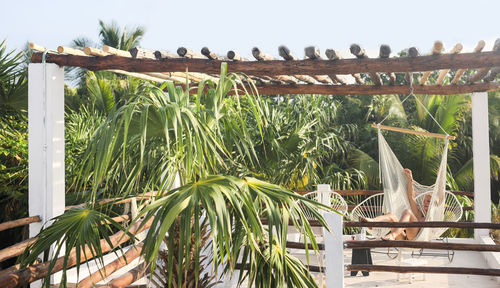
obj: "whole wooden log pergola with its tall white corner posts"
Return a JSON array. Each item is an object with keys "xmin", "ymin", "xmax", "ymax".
[{"xmin": 18, "ymin": 39, "xmax": 500, "ymax": 287}]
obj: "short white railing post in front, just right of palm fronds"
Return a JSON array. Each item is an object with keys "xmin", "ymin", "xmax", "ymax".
[{"xmin": 323, "ymin": 212, "xmax": 344, "ymax": 288}]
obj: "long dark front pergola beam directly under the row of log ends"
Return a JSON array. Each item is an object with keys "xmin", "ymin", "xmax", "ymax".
[{"xmin": 32, "ymin": 51, "xmax": 500, "ymax": 76}]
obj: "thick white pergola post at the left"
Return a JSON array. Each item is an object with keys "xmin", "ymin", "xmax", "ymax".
[{"xmin": 28, "ymin": 63, "xmax": 65, "ymax": 287}]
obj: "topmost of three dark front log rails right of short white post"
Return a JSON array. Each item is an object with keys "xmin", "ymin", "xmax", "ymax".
[{"xmin": 344, "ymin": 221, "xmax": 500, "ymax": 230}]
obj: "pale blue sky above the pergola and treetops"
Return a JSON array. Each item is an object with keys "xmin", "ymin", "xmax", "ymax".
[{"xmin": 0, "ymin": 0, "xmax": 500, "ymax": 59}]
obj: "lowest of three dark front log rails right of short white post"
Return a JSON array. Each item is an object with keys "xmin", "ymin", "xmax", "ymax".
[{"xmin": 346, "ymin": 264, "xmax": 500, "ymax": 276}]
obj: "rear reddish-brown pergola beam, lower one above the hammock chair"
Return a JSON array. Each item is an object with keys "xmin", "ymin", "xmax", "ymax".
[{"xmin": 250, "ymin": 82, "xmax": 498, "ymax": 95}]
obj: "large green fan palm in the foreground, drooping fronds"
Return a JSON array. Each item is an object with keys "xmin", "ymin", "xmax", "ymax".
[{"xmin": 22, "ymin": 64, "xmax": 325, "ymax": 287}]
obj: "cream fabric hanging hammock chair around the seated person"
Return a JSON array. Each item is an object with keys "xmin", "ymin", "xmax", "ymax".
[{"xmin": 378, "ymin": 128, "xmax": 448, "ymax": 241}]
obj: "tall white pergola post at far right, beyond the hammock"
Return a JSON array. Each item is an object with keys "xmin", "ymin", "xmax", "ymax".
[{"xmin": 471, "ymin": 92, "xmax": 491, "ymax": 240}]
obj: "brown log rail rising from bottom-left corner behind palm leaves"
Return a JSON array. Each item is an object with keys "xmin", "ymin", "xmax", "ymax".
[{"xmin": 0, "ymin": 218, "xmax": 153, "ymax": 288}]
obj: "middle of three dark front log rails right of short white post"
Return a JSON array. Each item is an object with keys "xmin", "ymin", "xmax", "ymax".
[{"xmin": 344, "ymin": 240, "xmax": 500, "ymax": 252}]
